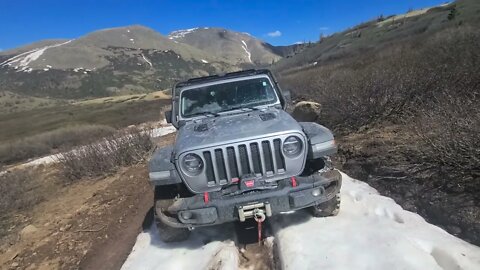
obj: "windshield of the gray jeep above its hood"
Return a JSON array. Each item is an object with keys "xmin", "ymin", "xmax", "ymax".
[{"xmin": 180, "ymin": 77, "xmax": 278, "ymax": 118}]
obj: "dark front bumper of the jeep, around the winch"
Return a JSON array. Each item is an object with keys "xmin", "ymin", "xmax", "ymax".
[{"xmin": 155, "ymin": 170, "xmax": 342, "ymax": 228}]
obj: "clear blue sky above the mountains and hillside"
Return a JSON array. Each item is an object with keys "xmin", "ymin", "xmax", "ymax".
[{"xmin": 0, "ymin": 0, "xmax": 445, "ymax": 50}]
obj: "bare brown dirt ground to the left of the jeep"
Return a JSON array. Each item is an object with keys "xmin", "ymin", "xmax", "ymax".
[{"xmin": 0, "ymin": 135, "xmax": 174, "ymax": 269}]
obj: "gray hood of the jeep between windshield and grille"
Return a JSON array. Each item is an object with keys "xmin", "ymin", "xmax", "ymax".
[{"xmin": 175, "ymin": 108, "xmax": 303, "ymax": 156}]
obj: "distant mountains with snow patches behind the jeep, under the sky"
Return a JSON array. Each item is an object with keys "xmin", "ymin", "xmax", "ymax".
[{"xmin": 0, "ymin": 25, "xmax": 281, "ymax": 99}]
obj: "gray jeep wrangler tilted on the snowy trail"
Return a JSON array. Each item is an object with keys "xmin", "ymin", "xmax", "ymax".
[{"xmin": 149, "ymin": 70, "xmax": 341, "ymax": 242}]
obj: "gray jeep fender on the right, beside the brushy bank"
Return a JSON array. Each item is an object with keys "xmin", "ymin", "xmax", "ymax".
[{"xmin": 299, "ymin": 122, "xmax": 337, "ymax": 159}]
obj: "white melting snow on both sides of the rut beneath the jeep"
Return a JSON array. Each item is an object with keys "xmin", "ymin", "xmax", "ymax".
[{"xmin": 122, "ymin": 174, "xmax": 480, "ymax": 270}]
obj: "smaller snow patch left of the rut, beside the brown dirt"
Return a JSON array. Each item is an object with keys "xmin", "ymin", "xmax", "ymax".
[{"xmin": 121, "ymin": 225, "xmax": 239, "ymax": 270}]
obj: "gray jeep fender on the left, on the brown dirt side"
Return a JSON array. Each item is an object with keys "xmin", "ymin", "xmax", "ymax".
[{"xmin": 148, "ymin": 145, "xmax": 182, "ymax": 186}]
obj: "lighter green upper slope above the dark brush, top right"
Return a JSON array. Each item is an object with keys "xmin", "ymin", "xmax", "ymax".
[{"xmin": 274, "ymin": 0, "xmax": 480, "ymax": 73}]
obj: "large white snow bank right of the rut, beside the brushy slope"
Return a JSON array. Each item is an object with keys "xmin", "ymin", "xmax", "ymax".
[{"xmin": 273, "ymin": 174, "xmax": 480, "ymax": 270}]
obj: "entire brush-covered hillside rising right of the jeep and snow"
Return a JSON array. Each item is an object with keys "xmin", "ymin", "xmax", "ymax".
[{"xmin": 274, "ymin": 0, "xmax": 480, "ymax": 245}]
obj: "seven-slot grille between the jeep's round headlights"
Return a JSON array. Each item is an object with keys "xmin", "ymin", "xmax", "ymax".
[{"xmin": 202, "ymin": 139, "xmax": 285, "ymax": 186}]
